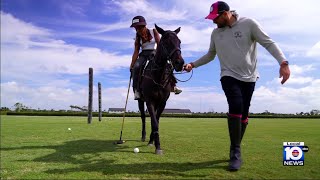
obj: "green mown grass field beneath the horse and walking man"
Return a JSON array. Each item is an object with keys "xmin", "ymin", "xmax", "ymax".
[{"xmin": 1, "ymin": 116, "xmax": 320, "ymax": 179}]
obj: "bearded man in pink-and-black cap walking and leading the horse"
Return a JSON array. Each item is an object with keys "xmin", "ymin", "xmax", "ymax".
[{"xmin": 185, "ymin": 1, "xmax": 290, "ymax": 171}]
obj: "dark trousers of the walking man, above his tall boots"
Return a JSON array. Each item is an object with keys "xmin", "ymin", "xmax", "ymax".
[{"xmin": 220, "ymin": 76, "xmax": 256, "ymax": 121}]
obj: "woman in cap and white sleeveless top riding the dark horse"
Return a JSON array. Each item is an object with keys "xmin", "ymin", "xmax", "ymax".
[{"xmin": 130, "ymin": 16, "xmax": 182, "ymax": 100}]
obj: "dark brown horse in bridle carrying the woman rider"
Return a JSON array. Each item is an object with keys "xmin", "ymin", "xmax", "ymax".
[{"xmin": 139, "ymin": 24, "xmax": 184, "ymax": 155}]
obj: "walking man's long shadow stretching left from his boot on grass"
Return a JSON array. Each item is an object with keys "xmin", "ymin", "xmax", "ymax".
[{"xmin": 46, "ymin": 160, "xmax": 227, "ymax": 178}]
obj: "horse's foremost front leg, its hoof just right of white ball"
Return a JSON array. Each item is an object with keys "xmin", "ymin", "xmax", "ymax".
[{"xmin": 147, "ymin": 102, "xmax": 162, "ymax": 154}]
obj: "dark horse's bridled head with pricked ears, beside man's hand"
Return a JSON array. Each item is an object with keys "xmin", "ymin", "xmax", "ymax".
[{"xmin": 155, "ymin": 24, "xmax": 184, "ymax": 71}]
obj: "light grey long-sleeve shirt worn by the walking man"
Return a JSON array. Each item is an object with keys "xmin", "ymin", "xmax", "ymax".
[{"xmin": 193, "ymin": 14, "xmax": 286, "ymax": 82}]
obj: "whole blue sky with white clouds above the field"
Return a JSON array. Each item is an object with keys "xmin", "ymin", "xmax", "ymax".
[{"xmin": 1, "ymin": 0, "xmax": 320, "ymax": 113}]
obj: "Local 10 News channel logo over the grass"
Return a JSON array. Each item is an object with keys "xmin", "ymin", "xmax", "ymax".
[{"xmin": 283, "ymin": 142, "xmax": 309, "ymax": 166}]
